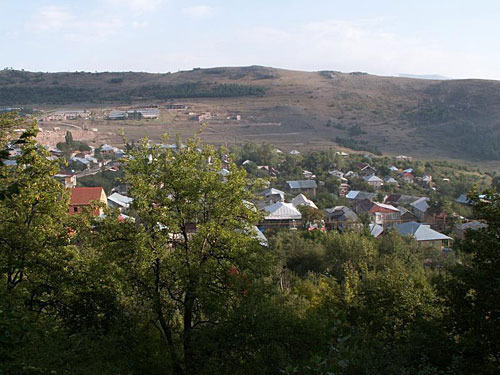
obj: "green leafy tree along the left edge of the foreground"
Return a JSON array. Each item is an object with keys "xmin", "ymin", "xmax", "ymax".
[{"xmin": 0, "ymin": 116, "xmax": 72, "ymax": 373}]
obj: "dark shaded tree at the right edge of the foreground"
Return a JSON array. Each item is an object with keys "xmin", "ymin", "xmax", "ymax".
[{"xmin": 444, "ymin": 191, "xmax": 500, "ymax": 374}]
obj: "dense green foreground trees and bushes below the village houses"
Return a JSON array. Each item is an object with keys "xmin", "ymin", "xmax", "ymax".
[{"xmin": 0, "ymin": 114, "xmax": 500, "ymax": 375}]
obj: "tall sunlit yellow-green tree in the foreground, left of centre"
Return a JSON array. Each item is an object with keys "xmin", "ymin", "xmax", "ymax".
[{"xmin": 88, "ymin": 135, "xmax": 266, "ymax": 374}]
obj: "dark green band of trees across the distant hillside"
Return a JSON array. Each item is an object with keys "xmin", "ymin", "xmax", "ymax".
[{"xmin": 0, "ymin": 82, "xmax": 265, "ymax": 105}]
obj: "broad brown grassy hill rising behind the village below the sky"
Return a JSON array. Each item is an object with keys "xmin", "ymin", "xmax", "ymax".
[{"xmin": 0, "ymin": 66, "xmax": 500, "ymax": 162}]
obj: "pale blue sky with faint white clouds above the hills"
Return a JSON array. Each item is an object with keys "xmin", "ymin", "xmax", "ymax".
[{"xmin": 0, "ymin": 0, "xmax": 500, "ymax": 80}]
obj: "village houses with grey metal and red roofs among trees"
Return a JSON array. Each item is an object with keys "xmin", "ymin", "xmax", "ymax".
[{"xmin": 3, "ymin": 125, "xmax": 485, "ymax": 251}]
